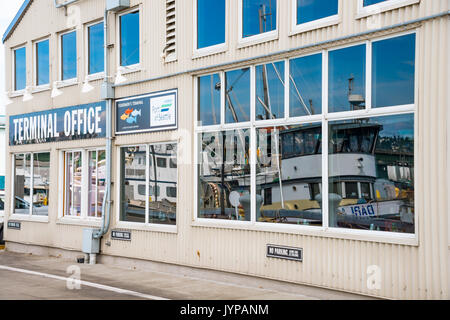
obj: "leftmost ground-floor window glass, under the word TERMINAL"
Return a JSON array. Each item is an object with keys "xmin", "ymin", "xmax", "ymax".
[{"xmin": 13, "ymin": 152, "xmax": 50, "ymax": 216}]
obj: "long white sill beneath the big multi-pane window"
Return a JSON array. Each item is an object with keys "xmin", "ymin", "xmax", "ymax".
[{"xmin": 191, "ymin": 219, "xmax": 419, "ymax": 246}]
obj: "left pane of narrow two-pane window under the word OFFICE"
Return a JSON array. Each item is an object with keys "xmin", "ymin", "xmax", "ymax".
[{"xmin": 65, "ymin": 152, "xmax": 83, "ymax": 217}]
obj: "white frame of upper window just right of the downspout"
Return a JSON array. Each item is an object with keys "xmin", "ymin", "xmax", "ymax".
[{"xmin": 116, "ymin": 4, "xmax": 143, "ymax": 75}]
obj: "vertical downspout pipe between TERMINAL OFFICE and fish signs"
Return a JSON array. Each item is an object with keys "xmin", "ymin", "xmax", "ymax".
[{"xmin": 93, "ymin": 9, "xmax": 114, "ymax": 239}]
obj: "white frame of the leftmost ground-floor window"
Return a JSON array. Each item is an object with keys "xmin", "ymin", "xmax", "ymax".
[{"xmin": 10, "ymin": 149, "xmax": 52, "ymax": 223}]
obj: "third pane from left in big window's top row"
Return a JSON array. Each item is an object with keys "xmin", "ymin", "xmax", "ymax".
[{"xmin": 255, "ymin": 61, "xmax": 284, "ymax": 120}]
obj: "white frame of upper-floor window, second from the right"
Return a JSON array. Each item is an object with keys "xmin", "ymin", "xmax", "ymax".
[{"xmin": 289, "ymin": 0, "xmax": 344, "ymax": 36}]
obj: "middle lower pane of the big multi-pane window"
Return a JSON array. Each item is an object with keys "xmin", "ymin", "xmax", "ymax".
[{"xmin": 256, "ymin": 124, "xmax": 322, "ymax": 226}]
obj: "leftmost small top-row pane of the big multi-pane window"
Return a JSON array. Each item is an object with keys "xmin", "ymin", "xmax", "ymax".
[{"xmin": 198, "ymin": 73, "xmax": 221, "ymax": 126}]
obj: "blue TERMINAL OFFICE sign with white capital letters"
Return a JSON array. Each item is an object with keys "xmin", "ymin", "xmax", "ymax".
[{"xmin": 9, "ymin": 101, "xmax": 106, "ymax": 146}]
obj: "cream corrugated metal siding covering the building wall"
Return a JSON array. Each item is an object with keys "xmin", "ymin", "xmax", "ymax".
[{"xmin": 6, "ymin": 0, "xmax": 449, "ymax": 299}]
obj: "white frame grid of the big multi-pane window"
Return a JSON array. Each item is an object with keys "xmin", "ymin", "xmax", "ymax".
[{"xmin": 191, "ymin": 29, "xmax": 421, "ymax": 246}]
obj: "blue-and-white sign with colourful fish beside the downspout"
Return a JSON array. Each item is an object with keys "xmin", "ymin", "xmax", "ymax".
[{"xmin": 116, "ymin": 89, "xmax": 178, "ymax": 134}]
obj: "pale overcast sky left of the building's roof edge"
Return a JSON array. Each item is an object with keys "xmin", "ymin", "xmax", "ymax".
[{"xmin": 0, "ymin": 0, "xmax": 24, "ymax": 114}]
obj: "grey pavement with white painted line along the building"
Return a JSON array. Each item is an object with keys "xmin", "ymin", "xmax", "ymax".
[{"xmin": 0, "ymin": 251, "xmax": 370, "ymax": 300}]
